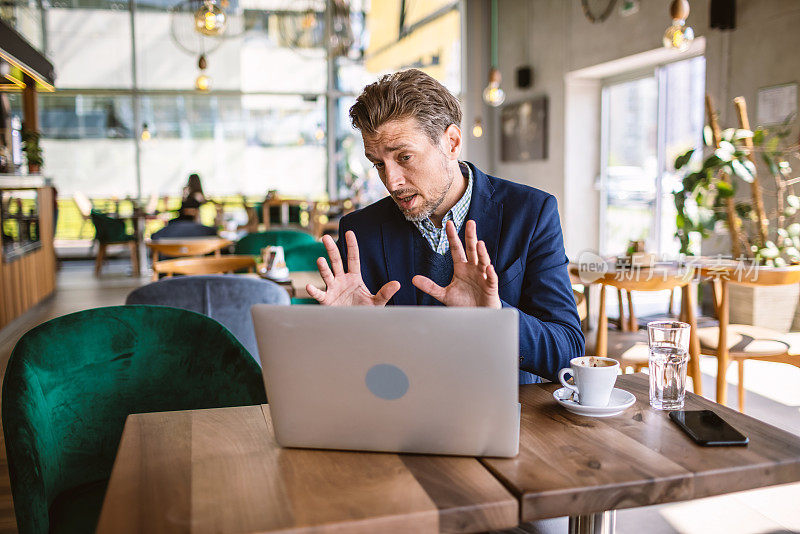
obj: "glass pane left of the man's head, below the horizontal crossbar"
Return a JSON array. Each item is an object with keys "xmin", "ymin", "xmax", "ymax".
[{"xmin": 141, "ymin": 95, "xmax": 326, "ymax": 197}]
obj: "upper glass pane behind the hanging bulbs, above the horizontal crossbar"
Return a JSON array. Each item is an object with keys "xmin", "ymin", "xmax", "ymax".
[{"xmin": 136, "ymin": 2, "xmax": 327, "ymax": 93}]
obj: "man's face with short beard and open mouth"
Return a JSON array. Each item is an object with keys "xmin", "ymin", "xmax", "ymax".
[{"xmin": 364, "ymin": 118, "xmax": 457, "ymax": 221}]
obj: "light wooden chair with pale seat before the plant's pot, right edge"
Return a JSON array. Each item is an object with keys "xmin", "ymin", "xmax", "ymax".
[{"xmin": 698, "ymin": 267, "xmax": 800, "ymax": 412}]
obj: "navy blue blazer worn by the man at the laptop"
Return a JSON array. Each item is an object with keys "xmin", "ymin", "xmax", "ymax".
[{"xmin": 339, "ymin": 163, "xmax": 585, "ymax": 383}]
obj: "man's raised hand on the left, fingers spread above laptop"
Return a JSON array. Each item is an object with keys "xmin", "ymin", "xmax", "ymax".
[{"xmin": 306, "ymin": 230, "xmax": 400, "ymax": 306}]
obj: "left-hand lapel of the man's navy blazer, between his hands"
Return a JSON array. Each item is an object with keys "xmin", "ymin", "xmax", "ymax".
[{"xmin": 382, "ymin": 217, "xmax": 417, "ymax": 306}]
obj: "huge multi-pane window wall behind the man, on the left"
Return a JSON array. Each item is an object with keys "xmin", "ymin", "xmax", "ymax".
[{"xmin": 0, "ymin": 0, "xmax": 461, "ymax": 240}]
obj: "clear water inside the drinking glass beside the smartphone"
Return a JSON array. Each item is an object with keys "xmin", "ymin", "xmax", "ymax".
[{"xmin": 649, "ymin": 344, "xmax": 689, "ymax": 410}]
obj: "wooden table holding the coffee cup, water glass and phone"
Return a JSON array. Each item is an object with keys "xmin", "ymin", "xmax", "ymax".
[{"xmin": 481, "ymin": 374, "xmax": 800, "ymax": 531}]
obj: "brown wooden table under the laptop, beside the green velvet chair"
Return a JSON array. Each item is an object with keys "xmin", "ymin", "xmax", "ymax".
[{"xmin": 97, "ymin": 405, "xmax": 518, "ymax": 534}]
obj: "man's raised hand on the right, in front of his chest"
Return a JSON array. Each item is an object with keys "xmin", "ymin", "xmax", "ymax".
[{"xmin": 411, "ymin": 221, "xmax": 501, "ymax": 308}]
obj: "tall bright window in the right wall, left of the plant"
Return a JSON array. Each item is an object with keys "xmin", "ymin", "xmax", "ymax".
[{"xmin": 600, "ymin": 57, "xmax": 705, "ymax": 255}]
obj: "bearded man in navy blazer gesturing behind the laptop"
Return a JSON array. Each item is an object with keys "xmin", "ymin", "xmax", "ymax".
[{"xmin": 307, "ymin": 69, "xmax": 584, "ymax": 384}]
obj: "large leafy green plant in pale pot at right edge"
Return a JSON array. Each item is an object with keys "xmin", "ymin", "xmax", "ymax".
[{"xmin": 673, "ymin": 99, "xmax": 800, "ymax": 330}]
